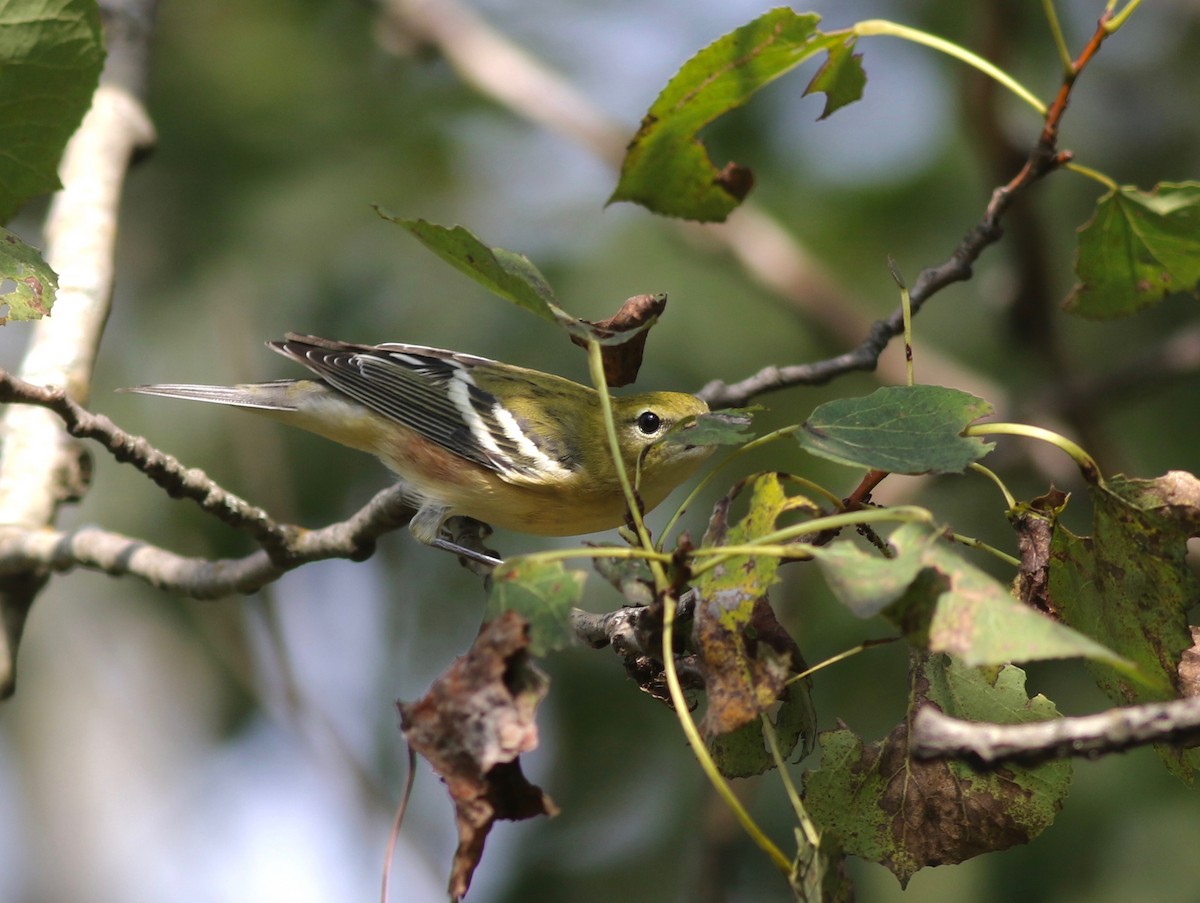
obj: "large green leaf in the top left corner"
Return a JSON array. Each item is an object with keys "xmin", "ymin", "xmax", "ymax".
[{"xmin": 0, "ymin": 0, "xmax": 104, "ymax": 222}]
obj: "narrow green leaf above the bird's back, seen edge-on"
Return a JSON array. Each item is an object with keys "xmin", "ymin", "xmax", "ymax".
[{"xmin": 376, "ymin": 216, "xmax": 658, "ymax": 345}]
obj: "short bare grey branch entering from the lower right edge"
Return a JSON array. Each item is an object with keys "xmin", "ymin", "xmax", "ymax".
[{"xmin": 910, "ymin": 696, "xmax": 1200, "ymax": 765}]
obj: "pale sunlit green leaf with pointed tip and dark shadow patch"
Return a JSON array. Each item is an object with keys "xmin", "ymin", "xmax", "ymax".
[{"xmin": 812, "ymin": 524, "xmax": 1138, "ymax": 675}]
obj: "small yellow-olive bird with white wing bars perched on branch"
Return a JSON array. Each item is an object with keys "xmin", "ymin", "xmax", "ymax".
[{"xmin": 128, "ymin": 333, "xmax": 713, "ymax": 552}]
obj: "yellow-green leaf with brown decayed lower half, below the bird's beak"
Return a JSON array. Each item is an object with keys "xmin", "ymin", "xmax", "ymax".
[{"xmin": 692, "ymin": 473, "xmax": 816, "ymax": 777}]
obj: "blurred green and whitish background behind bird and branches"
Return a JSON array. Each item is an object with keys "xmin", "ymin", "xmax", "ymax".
[{"xmin": 0, "ymin": 0, "xmax": 1200, "ymax": 903}]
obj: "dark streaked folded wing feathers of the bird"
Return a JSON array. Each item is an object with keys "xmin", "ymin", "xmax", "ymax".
[{"xmin": 268, "ymin": 333, "xmax": 536, "ymax": 476}]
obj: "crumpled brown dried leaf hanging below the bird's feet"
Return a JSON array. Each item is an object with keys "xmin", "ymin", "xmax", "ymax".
[{"xmin": 398, "ymin": 611, "xmax": 558, "ymax": 899}]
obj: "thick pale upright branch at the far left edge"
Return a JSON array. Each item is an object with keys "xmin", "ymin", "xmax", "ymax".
[{"xmin": 0, "ymin": 0, "xmax": 156, "ymax": 698}]
